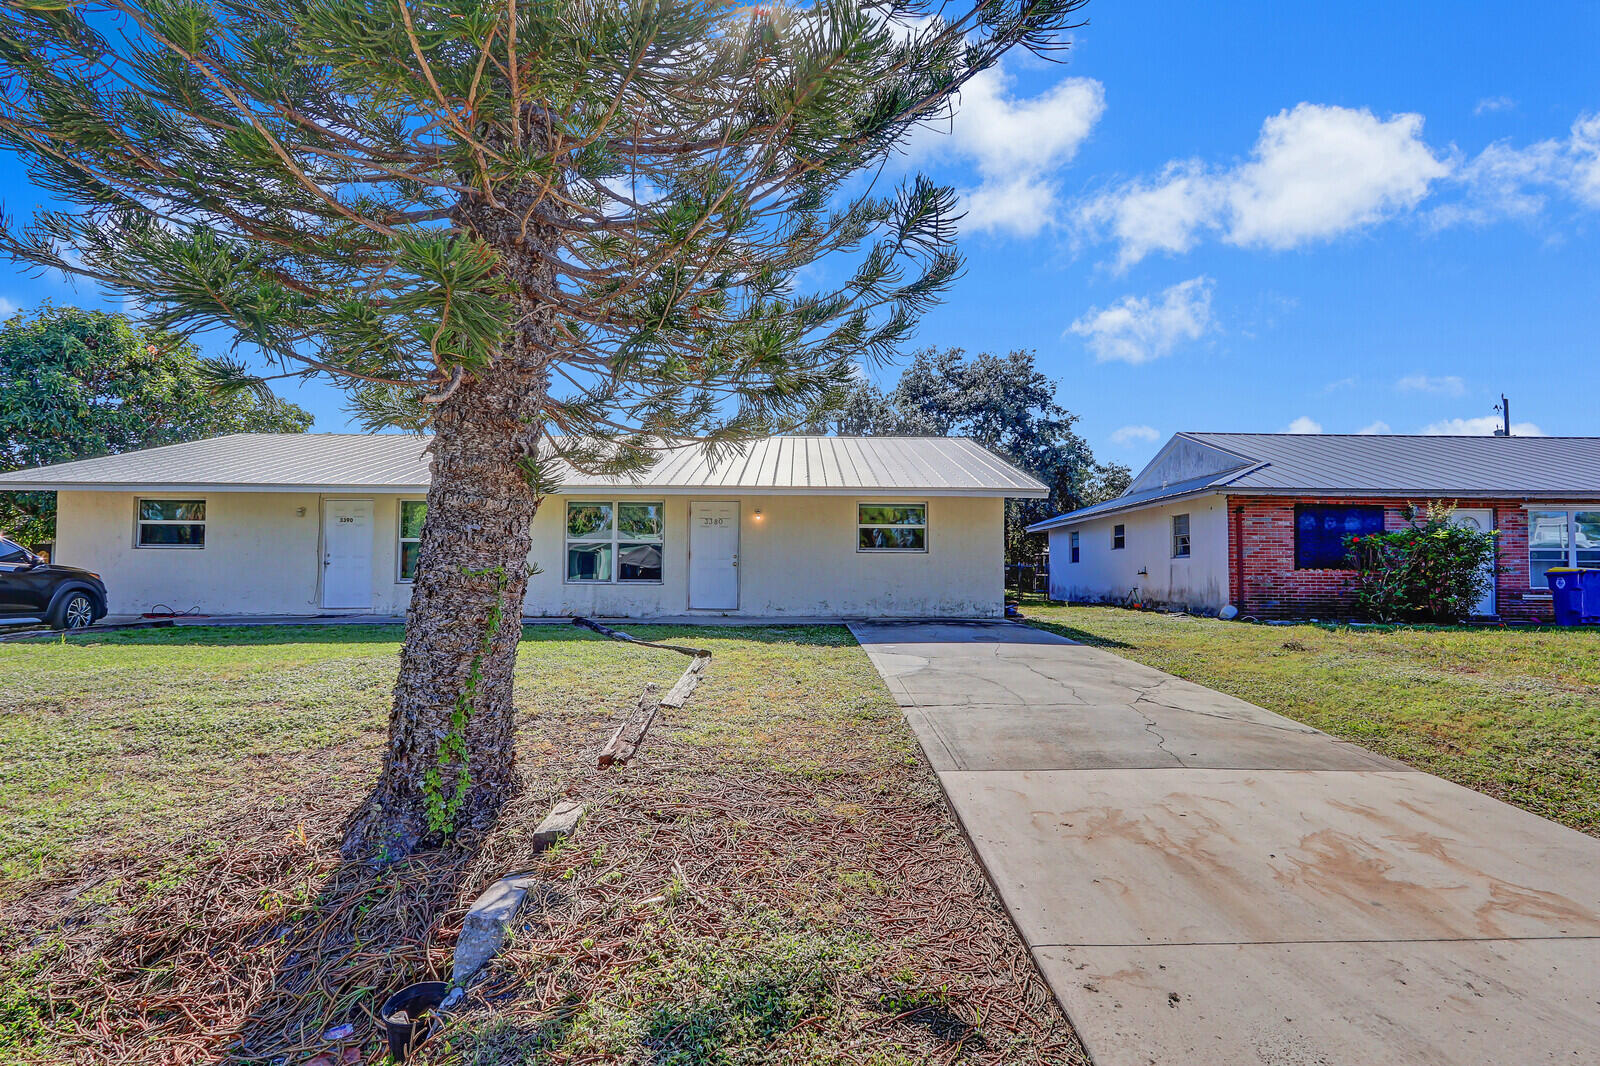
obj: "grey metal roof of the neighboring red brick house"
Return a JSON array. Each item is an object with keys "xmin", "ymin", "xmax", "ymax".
[{"xmin": 1029, "ymin": 432, "xmax": 1600, "ymax": 530}]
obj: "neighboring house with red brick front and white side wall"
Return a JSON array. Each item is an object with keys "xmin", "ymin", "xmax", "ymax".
[{"xmin": 1029, "ymin": 434, "xmax": 1600, "ymax": 621}]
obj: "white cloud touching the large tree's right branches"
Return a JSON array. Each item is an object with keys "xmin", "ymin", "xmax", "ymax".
[{"xmin": 910, "ymin": 67, "xmax": 1106, "ymax": 237}]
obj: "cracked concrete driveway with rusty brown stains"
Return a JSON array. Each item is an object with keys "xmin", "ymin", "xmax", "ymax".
[{"xmin": 851, "ymin": 623, "xmax": 1600, "ymax": 1066}]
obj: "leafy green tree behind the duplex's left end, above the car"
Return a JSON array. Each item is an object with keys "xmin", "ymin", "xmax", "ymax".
[{"xmin": 0, "ymin": 306, "xmax": 312, "ymax": 544}]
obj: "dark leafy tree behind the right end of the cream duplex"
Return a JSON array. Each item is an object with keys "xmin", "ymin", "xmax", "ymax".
[{"xmin": 822, "ymin": 347, "xmax": 1131, "ymax": 560}]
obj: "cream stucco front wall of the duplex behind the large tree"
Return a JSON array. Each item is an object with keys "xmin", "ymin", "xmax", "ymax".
[{"xmin": 54, "ymin": 491, "xmax": 1005, "ymax": 618}]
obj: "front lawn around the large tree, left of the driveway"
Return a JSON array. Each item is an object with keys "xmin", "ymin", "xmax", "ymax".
[{"xmin": 0, "ymin": 626, "xmax": 1083, "ymax": 1066}]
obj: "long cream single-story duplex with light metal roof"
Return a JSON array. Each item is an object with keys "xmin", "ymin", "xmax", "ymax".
[{"xmin": 0, "ymin": 434, "xmax": 1048, "ymax": 618}]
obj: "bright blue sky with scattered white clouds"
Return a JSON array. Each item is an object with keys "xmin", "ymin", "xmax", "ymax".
[{"xmin": 0, "ymin": 0, "xmax": 1600, "ymax": 466}]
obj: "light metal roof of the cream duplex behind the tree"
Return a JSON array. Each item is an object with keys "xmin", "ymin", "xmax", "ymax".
[{"xmin": 0, "ymin": 434, "xmax": 1050, "ymax": 498}]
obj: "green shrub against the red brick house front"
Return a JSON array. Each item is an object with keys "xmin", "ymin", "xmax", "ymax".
[{"xmin": 1344, "ymin": 501, "xmax": 1502, "ymax": 623}]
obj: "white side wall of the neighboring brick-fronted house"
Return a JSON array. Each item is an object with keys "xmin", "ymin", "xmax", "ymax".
[{"xmin": 1050, "ymin": 496, "xmax": 1227, "ymax": 611}]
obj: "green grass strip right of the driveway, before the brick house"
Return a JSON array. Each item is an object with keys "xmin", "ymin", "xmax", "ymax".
[{"xmin": 1022, "ymin": 599, "xmax": 1600, "ymax": 834}]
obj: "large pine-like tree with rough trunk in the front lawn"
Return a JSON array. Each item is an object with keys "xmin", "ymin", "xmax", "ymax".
[{"xmin": 0, "ymin": 0, "xmax": 1083, "ymax": 860}]
